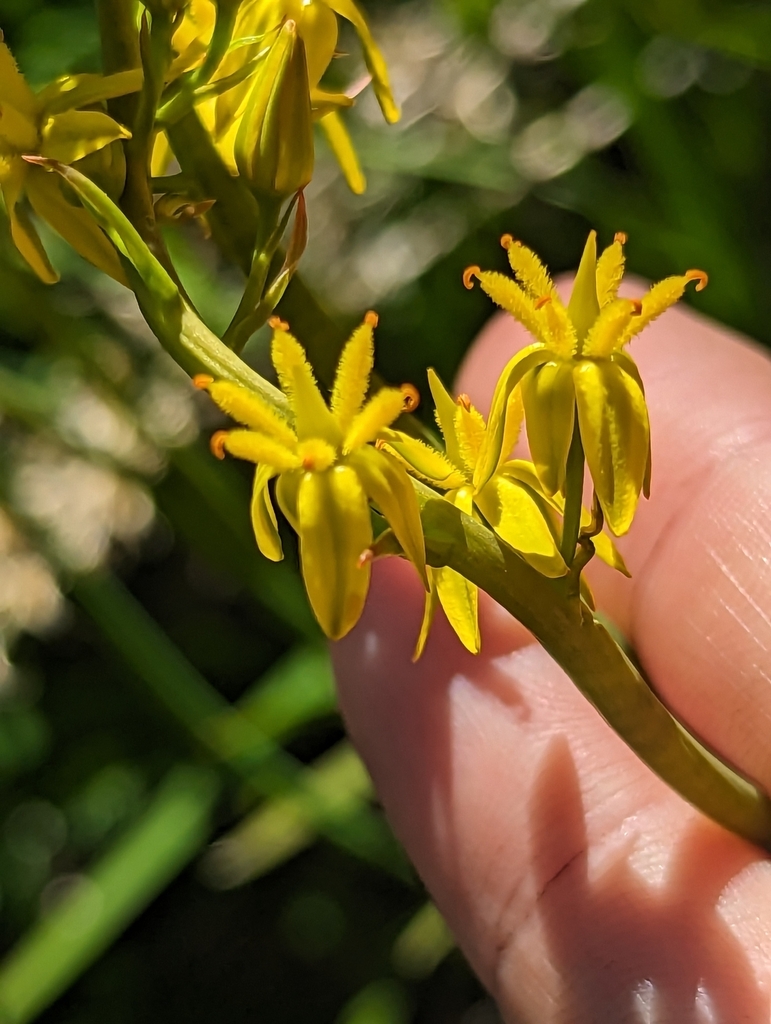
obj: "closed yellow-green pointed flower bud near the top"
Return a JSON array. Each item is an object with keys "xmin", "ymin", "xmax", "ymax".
[{"xmin": 235, "ymin": 20, "xmax": 313, "ymax": 198}]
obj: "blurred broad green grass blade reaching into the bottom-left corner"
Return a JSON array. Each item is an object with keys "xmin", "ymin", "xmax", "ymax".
[{"xmin": 0, "ymin": 766, "xmax": 218, "ymax": 1024}]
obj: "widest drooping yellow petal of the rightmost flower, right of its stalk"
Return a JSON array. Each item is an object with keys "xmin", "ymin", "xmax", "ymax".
[{"xmin": 573, "ymin": 360, "xmax": 649, "ymax": 537}]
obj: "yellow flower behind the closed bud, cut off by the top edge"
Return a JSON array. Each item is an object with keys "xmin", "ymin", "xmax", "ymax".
[{"xmin": 165, "ymin": 0, "xmax": 399, "ymax": 194}]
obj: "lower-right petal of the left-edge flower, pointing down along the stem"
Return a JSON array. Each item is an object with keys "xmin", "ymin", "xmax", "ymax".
[{"xmin": 27, "ymin": 167, "xmax": 128, "ymax": 288}]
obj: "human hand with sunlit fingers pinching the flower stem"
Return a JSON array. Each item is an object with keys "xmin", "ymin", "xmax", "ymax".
[{"xmin": 334, "ymin": 294, "xmax": 771, "ymax": 1024}]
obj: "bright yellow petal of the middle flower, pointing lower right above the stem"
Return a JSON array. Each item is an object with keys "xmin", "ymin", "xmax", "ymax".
[{"xmin": 476, "ymin": 474, "xmax": 567, "ymax": 577}]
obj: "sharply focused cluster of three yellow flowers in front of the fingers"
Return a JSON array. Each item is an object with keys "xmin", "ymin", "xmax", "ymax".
[{"xmin": 197, "ymin": 231, "xmax": 706, "ymax": 656}]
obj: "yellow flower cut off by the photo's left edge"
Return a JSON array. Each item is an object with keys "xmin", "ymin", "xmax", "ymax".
[{"xmin": 0, "ymin": 42, "xmax": 141, "ymax": 284}]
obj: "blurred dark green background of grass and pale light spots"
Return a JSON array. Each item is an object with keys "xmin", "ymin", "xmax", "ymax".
[{"xmin": 0, "ymin": 0, "xmax": 771, "ymax": 1024}]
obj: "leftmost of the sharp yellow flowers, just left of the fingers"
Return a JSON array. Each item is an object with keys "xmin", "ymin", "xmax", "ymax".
[{"xmin": 195, "ymin": 313, "xmax": 425, "ymax": 640}]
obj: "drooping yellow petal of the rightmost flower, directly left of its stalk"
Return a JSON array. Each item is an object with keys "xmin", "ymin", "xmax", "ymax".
[{"xmin": 522, "ymin": 362, "xmax": 575, "ymax": 495}]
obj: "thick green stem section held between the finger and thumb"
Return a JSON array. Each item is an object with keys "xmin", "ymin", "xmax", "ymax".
[{"xmin": 416, "ymin": 491, "xmax": 771, "ymax": 851}]
